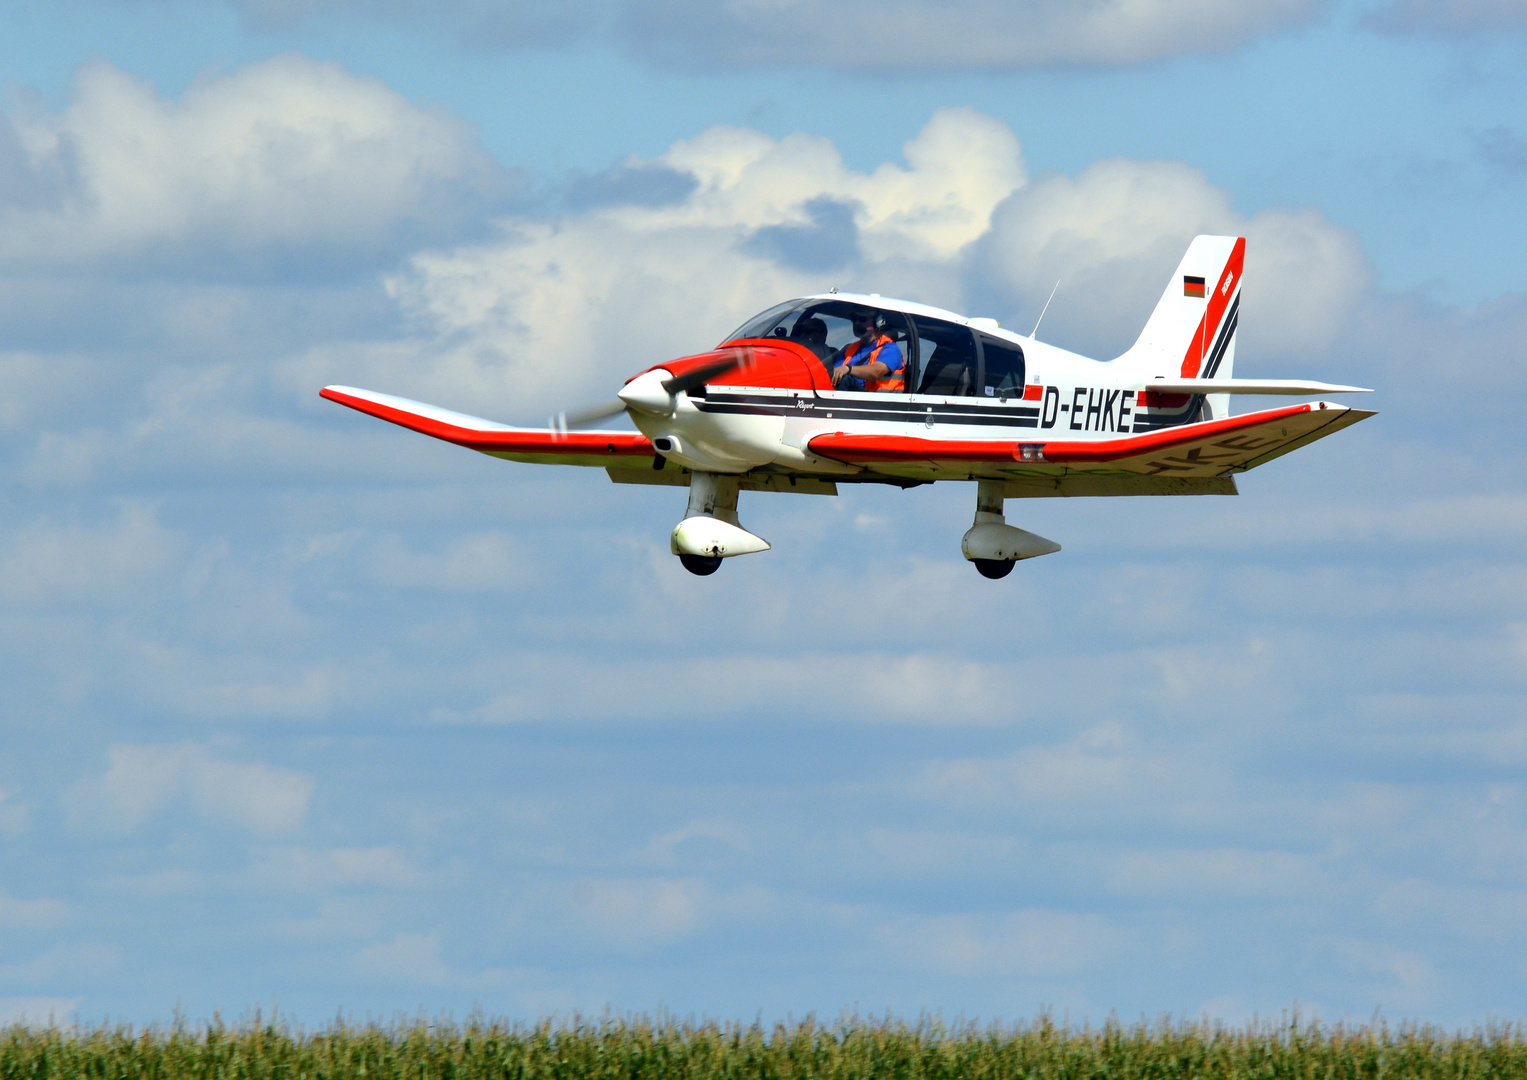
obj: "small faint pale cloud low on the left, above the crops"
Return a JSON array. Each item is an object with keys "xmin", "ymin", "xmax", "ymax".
[{"xmin": 64, "ymin": 744, "xmax": 313, "ymax": 834}]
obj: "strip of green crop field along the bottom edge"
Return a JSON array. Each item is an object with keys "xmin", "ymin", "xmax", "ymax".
[{"xmin": 0, "ymin": 1016, "xmax": 1527, "ymax": 1080}]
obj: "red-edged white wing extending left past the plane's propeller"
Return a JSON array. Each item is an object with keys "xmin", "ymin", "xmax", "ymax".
[{"xmin": 318, "ymin": 386, "xmax": 655, "ymax": 467}]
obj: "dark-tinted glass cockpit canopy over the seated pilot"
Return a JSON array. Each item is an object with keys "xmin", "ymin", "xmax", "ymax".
[{"xmin": 722, "ymin": 298, "xmax": 1023, "ymax": 397}]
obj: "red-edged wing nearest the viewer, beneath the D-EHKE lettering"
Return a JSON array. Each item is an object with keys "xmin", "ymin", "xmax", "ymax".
[{"xmin": 809, "ymin": 402, "xmax": 1374, "ymax": 495}]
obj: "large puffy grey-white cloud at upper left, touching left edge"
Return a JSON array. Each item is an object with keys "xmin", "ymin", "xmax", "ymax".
[{"xmin": 0, "ymin": 55, "xmax": 505, "ymax": 272}]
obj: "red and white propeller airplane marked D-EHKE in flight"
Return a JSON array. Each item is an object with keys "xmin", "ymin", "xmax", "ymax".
[{"xmin": 319, "ymin": 235, "xmax": 1374, "ymax": 579}]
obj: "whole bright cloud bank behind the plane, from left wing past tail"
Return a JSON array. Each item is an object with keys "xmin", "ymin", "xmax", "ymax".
[{"xmin": 303, "ymin": 108, "xmax": 1371, "ymax": 422}]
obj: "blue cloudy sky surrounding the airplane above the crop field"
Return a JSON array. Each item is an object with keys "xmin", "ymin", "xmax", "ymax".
[{"xmin": 0, "ymin": 0, "xmax": 1527, "ymax": 1027}]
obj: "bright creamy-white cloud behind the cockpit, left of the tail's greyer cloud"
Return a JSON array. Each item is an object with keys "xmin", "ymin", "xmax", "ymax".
[{"xmin": 305, "ymin": 110, "xmax": 1023, "ymax": 422}]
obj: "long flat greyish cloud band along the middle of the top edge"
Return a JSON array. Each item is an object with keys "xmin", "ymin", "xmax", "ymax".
[{"xmin": 143, "ymin": 0, "xmax": 1325, "ymax": 67}]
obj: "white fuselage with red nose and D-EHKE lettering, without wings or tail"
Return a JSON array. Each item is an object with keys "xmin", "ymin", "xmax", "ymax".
[{"xmin": 631, "ymin": 293, "xmax": 1206, "ymax": 477}]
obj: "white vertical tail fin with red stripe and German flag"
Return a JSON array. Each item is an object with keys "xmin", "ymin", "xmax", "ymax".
[{"xmin": 1115, "ymin": 237, "xmax": 1246, "ymax": 420}]
